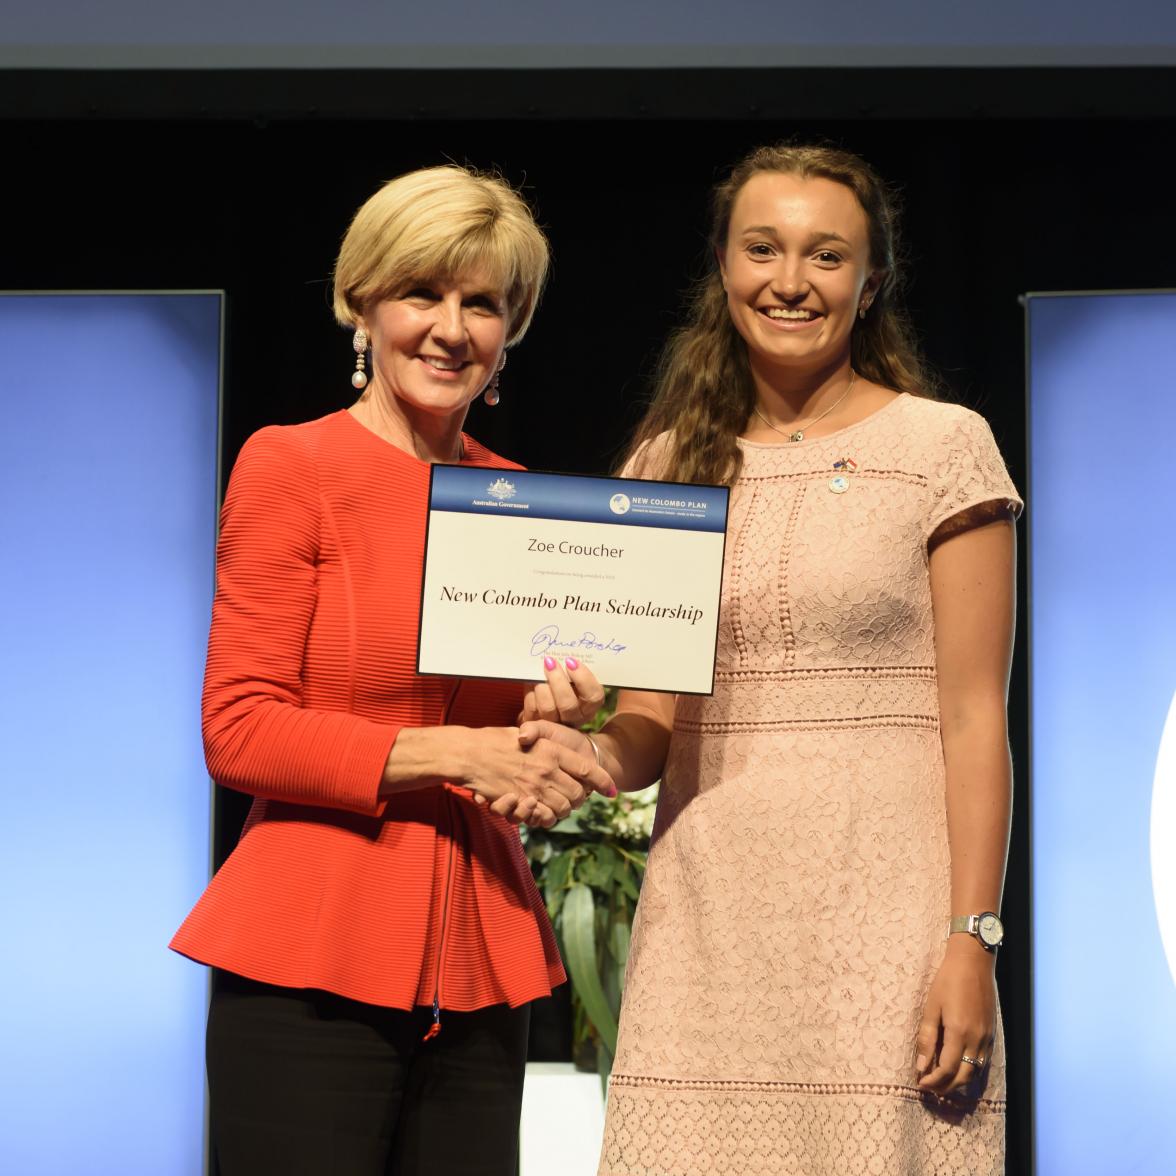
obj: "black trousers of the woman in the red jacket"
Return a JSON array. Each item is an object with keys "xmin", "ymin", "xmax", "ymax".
[{"xmin": 208, "ymin": 976, "xmax": 530, "ymax": 1176}]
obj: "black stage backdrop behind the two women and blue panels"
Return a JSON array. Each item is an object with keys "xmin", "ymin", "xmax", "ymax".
[{"xmin": 0, "ymin": 69, "xmax": 1176, "ymax": 1174}]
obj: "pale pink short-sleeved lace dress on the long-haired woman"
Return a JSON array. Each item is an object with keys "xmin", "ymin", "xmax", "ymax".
[{"xmin": 600, "ymin": 395, "xmax": 1021, "ymax": 1176}]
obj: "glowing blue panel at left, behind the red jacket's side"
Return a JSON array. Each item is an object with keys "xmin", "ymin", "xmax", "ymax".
[{"xmin": 0, "ymin": 294, "xmax": 221, "ymax": 1176}]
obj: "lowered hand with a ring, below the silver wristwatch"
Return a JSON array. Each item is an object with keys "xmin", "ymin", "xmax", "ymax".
[{"xmin": 915, "ymin": 935, "xmax": 996, "ymax": 1098}]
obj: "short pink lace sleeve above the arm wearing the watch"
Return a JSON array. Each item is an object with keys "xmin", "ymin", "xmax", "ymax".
[{"xmin": 926, "ymin": 407, "xmax": 1024, "ymax": 539}]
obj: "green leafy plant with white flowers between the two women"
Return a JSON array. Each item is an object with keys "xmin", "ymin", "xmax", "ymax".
[{"xmin": 524, "ymin": 697, "xmax": 657, "ymax": 1082}]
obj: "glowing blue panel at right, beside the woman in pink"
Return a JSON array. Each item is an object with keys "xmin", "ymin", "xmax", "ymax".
[{"xmin": 1028, "ymin": 293, "xmax": 1176, "ymax": 1176}]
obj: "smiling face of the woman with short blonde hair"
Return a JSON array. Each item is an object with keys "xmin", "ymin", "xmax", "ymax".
[{"xmin": 358, "ymin": 273, "xmax": 508, "ymax": 416}]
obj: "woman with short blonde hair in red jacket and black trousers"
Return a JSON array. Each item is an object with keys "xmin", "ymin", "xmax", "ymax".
[{"xmin": 172, "ymin": 167, "xmax": 613, "ymax": 1176}]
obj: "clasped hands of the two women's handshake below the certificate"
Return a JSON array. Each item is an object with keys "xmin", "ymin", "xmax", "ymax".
[{"xmin": 453, "ymin": 727, "xmax": 616, "ymax": 828}]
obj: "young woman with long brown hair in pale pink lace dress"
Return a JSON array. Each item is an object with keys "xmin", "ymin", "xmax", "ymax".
[{"xmin": 555, "ymin": 145, "xmax": 1021, "ymax": 1176}]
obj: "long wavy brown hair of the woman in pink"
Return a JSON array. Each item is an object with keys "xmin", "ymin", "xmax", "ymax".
[{"xmin": 623, "ymin": 142, "xmax": 938, "ymax": 485}]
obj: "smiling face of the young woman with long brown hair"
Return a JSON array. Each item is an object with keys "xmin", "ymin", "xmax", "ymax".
[{"xmin": 719, "ymin": 172, "xmax": 877, "ymax": 381}]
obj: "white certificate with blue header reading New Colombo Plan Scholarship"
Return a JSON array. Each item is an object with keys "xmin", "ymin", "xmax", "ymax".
[{"xmin": 416, "ymin": 466, "xmax": 728, "ymax": 694}]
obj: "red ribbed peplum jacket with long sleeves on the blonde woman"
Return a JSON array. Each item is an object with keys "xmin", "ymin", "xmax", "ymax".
[{"xmin": 172, "ymin": 412, "xmax": 564, "ymax": 1011}]
